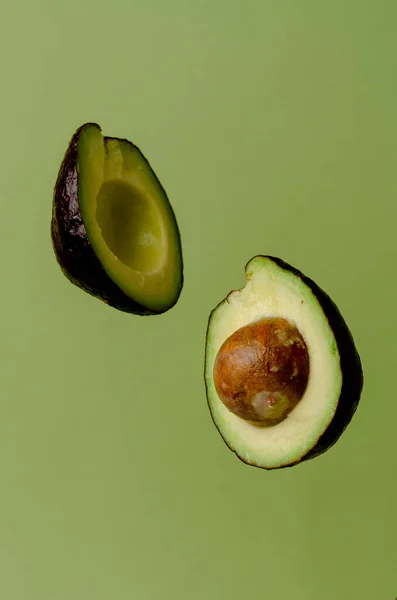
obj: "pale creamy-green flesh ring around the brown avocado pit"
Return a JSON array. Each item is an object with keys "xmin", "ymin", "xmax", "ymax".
[{"xmin": 205, "ymin": 257, "xmax": 342, "ymax": 468}]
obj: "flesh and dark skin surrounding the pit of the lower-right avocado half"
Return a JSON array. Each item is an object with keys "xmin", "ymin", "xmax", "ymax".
[{"xmin": 205, "ymin": 256, "xmax": 363, "ymax": 469}]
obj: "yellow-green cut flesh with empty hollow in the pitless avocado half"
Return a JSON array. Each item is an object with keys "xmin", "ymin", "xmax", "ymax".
[{"xmin": 74, "ymin": 125, "xmax": 181, "ymax": 310}]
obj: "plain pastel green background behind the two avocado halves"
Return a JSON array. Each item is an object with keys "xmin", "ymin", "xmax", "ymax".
[{"xmin": 0, "ymin": 0, "xmax": 397, "ymax": 600}]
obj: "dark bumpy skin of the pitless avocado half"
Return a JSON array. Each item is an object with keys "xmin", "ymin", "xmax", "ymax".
[{"xmin": 51, "ymin": 123, "xmax": 183, "ymax": 316}]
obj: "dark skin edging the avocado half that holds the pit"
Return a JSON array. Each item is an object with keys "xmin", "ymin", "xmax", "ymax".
[{"xmin": 207, "ymin": 255, "xmax": 364, "ymax": 471}]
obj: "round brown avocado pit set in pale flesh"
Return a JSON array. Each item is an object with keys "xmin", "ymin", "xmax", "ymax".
[{"xmin": 214, "ymin": 318, "xmax": 310, "ymax": 425}]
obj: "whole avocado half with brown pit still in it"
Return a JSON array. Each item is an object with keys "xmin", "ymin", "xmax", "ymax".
[{"xmin": 205, "ymin": 256, "xmax": 363, "ymax": 469}]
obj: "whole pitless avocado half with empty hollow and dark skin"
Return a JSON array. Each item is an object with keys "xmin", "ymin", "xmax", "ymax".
[{"xmin": 51, "ymin": 123, "xmax": 183, "ymax": 315}]
